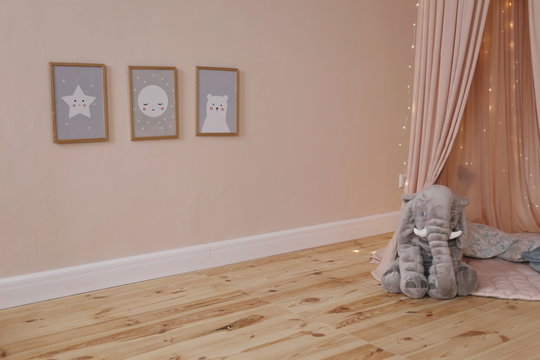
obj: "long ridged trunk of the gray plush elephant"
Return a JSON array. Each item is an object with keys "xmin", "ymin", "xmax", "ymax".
[{"xmin": 426, "ymin": 219, "xmax": 457, "ymax": 299}]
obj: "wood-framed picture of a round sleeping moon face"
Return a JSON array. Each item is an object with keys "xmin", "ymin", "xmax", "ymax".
[{"xmin": 129, "ymin": 66, "xmax": 178, "ymax": 140}]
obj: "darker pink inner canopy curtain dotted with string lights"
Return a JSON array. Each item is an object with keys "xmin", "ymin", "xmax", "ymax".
[{"xmin": 439, "ymin": 0, "xmax": 540, "ymax": 232}]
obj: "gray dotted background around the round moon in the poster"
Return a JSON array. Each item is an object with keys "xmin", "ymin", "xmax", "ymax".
[{"xmin": 131, "ymin": 69, "xmax": 177, "ymax": 137}]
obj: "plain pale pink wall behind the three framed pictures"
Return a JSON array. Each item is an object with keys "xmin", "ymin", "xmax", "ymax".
[{"xmin": 0, "ymin": 0, "xmax": 416, "ymax": 277}]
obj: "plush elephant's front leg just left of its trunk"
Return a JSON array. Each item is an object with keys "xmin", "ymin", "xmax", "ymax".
[{"xmin": 398, "ymin": 244, "xmax": 427, "ymax": 299}]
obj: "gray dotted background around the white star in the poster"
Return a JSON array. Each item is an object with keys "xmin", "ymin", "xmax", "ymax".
[{"xmin": 53, "ymin": 65, "xmax": 105, "ymax": 140}]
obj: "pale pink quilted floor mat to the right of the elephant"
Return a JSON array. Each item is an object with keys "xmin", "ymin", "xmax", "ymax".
[{"xmin": 467, "ymin": 259, "xmax": 540, "ymax": 301}]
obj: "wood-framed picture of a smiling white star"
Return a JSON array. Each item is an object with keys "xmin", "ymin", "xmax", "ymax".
[{"xmin": 49, "ymin": 62, "xmax": 109, "ymax": 144}]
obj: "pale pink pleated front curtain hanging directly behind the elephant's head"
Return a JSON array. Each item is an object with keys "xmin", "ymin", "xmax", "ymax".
[{"xmin": 373, "ymin": 0, "xmax": 489, "ymax": 280}]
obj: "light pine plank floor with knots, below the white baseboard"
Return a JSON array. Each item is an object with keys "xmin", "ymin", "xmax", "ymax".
[{"xmin": 0, "ymin": 235, "xmax": 540, "ymax": 360}]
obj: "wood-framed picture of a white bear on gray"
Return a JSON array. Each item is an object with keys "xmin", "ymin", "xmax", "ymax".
[{"xmin": 196, "ymin": 66, "xmax": 239, "ymax": 136}]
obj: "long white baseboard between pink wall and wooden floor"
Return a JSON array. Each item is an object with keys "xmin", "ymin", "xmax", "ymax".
[{"xmin": 0, "ymin": 212, "xmax": 399, "ymax": 309}]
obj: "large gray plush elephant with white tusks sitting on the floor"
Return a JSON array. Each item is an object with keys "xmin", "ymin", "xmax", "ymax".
[{"xmin": 382, "ymin": 185, "xmax": 478, "ymax": 299}]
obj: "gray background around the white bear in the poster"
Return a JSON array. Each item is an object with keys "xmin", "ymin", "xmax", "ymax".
[{"xmin": 198, "ymin": 69, "xmax": 237, "ymax": 133}]
